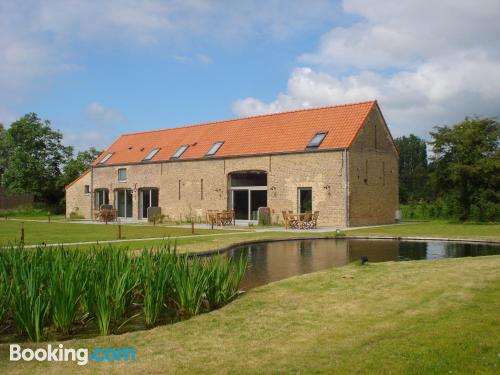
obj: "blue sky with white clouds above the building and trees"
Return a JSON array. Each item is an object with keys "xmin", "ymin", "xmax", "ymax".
[{"xmin": 0, "ymin": 0, "xmax": 500, "ymax": 150}]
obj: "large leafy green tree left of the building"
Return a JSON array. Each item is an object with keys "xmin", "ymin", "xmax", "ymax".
[{"xmin": 3, "ymin": 113, "xmax": 72, "ymax": 204}]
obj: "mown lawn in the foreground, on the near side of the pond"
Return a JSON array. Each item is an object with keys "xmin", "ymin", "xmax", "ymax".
[{"xmin": 0, "ymin": 256, "xmax": 500, "ymax": 374}]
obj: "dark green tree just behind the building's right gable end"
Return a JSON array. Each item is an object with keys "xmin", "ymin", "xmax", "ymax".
[{"xmin": 394, "ymin": 134, "xmax": 428, "ymax": 203}]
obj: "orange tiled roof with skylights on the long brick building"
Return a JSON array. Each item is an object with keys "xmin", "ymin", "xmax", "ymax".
[{"xmin": 94, "ymin": 101, "xmax": 376, "ymax": 165}]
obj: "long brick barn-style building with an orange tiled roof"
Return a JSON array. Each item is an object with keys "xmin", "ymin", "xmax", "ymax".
[{"xmin": 66, "ymin": 101, "xmax": 398, "ymax": 227}]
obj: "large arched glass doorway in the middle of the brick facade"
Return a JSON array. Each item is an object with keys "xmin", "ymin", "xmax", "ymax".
[{"xmin": 228, "ymin": 171, "xmax": 267, "ymax": 224}]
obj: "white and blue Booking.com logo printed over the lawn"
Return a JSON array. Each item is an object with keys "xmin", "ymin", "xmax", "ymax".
[{"xmin": 10, "ymin": 344, "xmax": 136, "ymax": 366}]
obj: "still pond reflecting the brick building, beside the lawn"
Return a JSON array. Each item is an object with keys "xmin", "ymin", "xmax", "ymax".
[{"xmin": 230, "ymin": 239, "xmax": 500, "ymax": 290}]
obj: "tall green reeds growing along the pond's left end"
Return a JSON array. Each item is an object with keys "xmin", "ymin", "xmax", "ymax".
[{"xmin": 0, "ymin": 245, "xmax": 247, "ymax": 341}]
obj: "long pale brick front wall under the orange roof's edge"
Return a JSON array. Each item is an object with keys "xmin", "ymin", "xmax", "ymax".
[{"xmin": 66, "ymin": 151, "xmax": 345, "ymax": 226}]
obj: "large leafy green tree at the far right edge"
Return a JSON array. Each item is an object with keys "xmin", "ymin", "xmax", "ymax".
[{"xmin": 430, "ymin": 117, "xmax": 500, "ymax": 220}]
